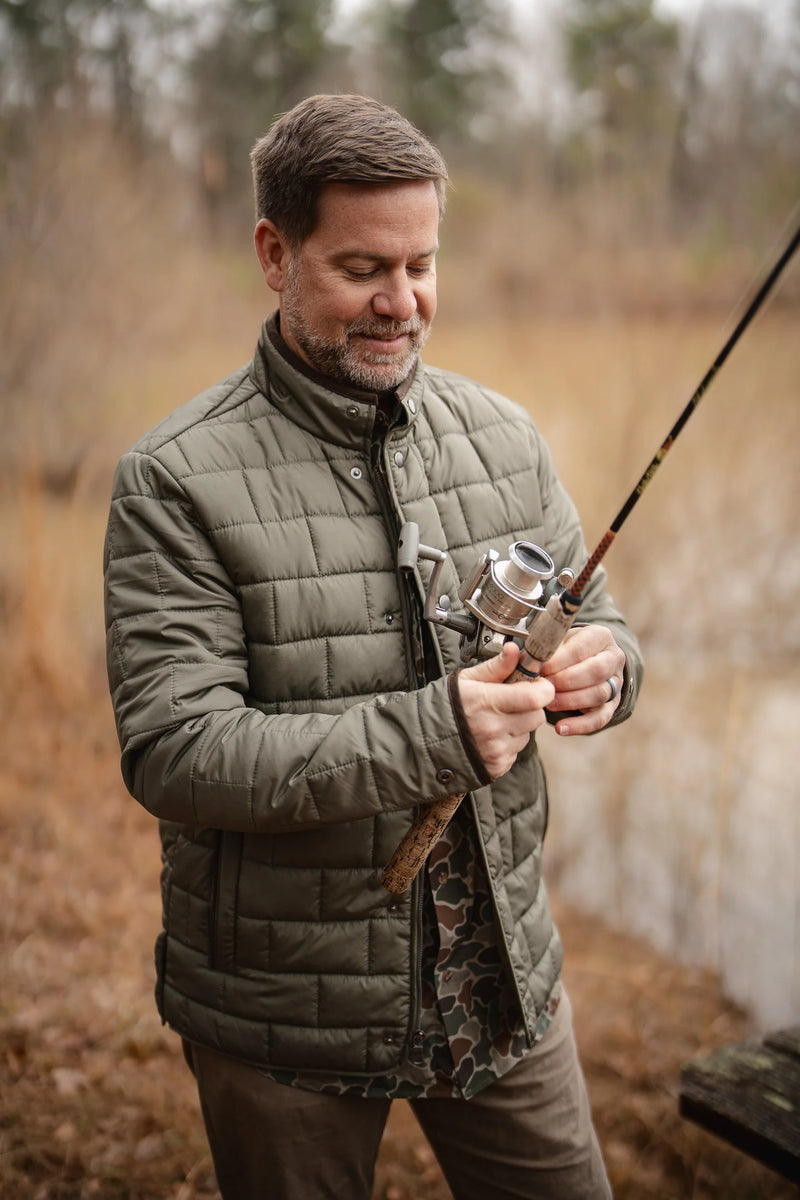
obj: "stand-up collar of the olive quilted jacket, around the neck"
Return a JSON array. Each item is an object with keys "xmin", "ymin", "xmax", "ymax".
[{"xmin": 251, "ymin": 313, "xmax": 425, "ymax": 446}]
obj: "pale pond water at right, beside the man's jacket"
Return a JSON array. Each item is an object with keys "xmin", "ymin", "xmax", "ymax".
[{"xmin": 540, "ymin": 656, "xmax": 800, "ymax": 1030}]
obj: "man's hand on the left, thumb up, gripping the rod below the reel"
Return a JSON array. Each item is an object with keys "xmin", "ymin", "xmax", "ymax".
[{"xmin": 457, "ymin": 642, "xmax": 555, "ymax": 779}]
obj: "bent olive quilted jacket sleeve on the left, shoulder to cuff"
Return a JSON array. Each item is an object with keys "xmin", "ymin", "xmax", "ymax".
[{"xmin": 104, "ymin": 451, "xmax": 483, "ymax": 833}]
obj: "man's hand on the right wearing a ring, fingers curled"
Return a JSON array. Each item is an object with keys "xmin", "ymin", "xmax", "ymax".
[{"xmin": 541, "ymin": 625, "xmax": 625, "ymax": 737}]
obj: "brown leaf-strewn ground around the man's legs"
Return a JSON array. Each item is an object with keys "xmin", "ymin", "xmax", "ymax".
[{"xmin": 0, "ymin": 680, "xmax": 796, "ymax": 1200}]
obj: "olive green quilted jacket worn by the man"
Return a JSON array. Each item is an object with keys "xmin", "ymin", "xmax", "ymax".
[{"xmin": 106, "ymin": 324, "xmax": 640, "ymax": 1075}]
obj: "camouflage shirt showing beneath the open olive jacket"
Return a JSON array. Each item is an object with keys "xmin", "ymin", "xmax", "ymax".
[{"xmin": 265, "ymin": 804, "xmax": 560, "ymax": 1099}]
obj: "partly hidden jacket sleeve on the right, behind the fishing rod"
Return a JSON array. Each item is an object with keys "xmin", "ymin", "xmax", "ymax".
[{"xmin": 539, "ymin": 442, "xmax": 644, "ymax": 728}]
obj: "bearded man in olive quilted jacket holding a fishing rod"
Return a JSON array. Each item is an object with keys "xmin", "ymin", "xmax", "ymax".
[{"xmin": 106, "ymin": 96, "xmax": 640, "ymax": 1200}]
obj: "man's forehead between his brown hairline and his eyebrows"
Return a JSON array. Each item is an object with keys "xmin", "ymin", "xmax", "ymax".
[{"xmin": 307, "ymin": 179, "xmax": 439, "ymax": 253}]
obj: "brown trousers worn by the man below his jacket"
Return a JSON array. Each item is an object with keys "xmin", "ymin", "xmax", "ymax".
[{"xmin": 185, "ymin": 994, "xmax": 610, "ymax": 1200}]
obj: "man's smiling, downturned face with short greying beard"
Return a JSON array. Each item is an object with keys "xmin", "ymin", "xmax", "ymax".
[{"xmin": 273, "ymin": 180, "xmax": 439, "ymax": 391}]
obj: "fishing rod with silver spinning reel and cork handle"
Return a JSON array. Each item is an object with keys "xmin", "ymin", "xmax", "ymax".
[{"xmin": 383, "ymin": 216, "xmax": 800, "ymax": 895}]
